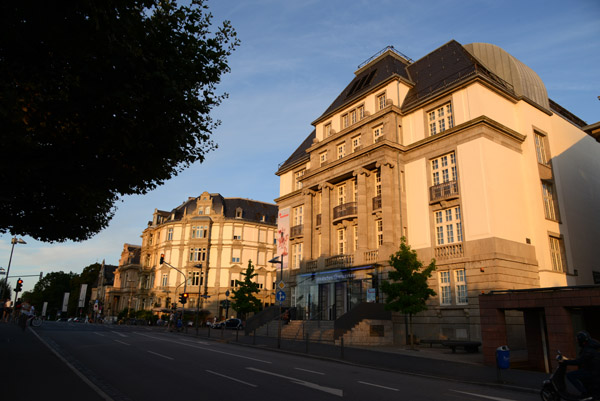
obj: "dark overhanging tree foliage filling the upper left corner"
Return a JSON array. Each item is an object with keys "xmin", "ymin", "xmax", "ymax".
[{"xmin": 0, "ymin": 0, "xmax": 239, "ymax": 242}]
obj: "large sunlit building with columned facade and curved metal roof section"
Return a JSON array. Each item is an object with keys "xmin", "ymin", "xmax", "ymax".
[{"xmin": 276, "ymin": 40, "xmax": 600, "ymax": 340}]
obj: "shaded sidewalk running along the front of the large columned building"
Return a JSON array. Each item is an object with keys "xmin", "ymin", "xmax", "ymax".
[{"xmin": 185, "ymin": 329, "xmax": 548, "ymax": 393}]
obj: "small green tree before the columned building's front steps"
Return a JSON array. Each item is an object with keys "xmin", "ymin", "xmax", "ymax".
[{"xmin": 381, "ymin": 237, "xmax": 436, "ymax": 348}]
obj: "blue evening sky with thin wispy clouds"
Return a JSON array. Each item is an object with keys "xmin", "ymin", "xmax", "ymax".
[{"xmin": 0, "ymin": 0, "xmax": 600, "ymax": 290}]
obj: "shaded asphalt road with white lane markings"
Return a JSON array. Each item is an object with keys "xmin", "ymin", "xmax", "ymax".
[{"xmin": 29, "ymin": 322, "xmax": 539, "ymax": 401}]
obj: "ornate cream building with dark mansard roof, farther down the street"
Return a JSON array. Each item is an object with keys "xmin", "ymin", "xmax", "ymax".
[{"xmin": 107, "ymin": 192, "xmax": 277, "ymax": 317}]
